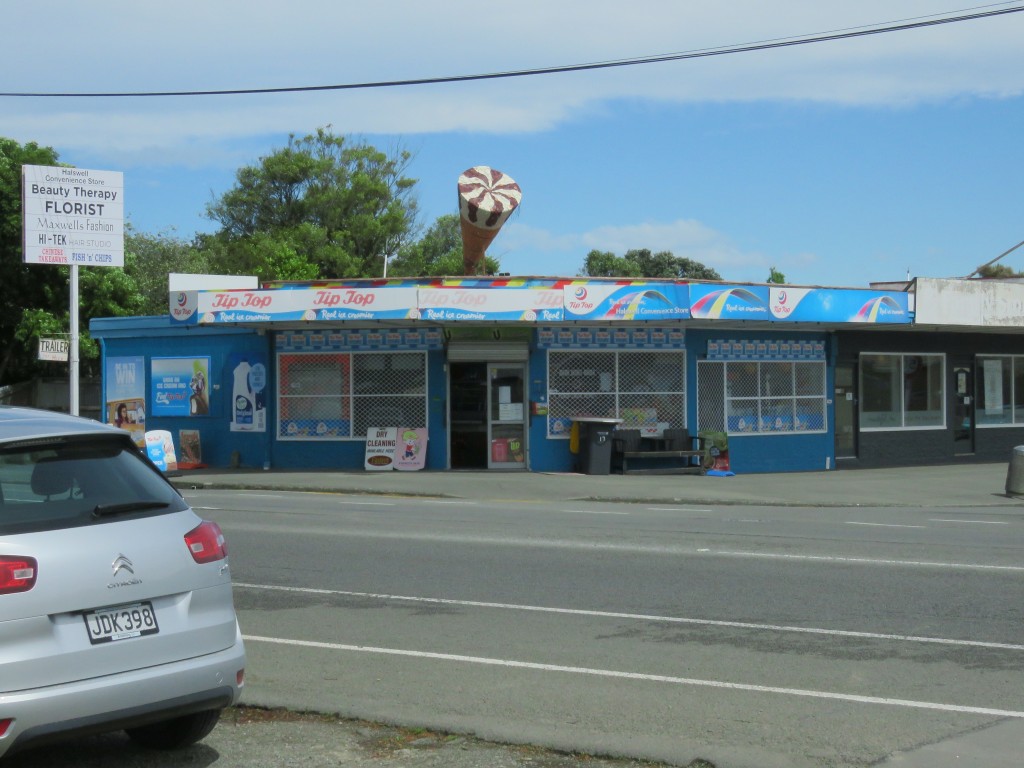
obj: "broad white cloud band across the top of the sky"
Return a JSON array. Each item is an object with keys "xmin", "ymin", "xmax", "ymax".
[{"xmin": 0, "ymin": 0, "xmax": 1024, "ymax": 160}]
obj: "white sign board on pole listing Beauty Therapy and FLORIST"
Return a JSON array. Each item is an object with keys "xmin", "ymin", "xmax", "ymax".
[{"xmin": 22, "ymin": 165, "xmax": 125, "ymax": 266}]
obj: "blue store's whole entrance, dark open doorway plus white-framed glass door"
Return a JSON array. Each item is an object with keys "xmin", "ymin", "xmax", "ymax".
[{"xmin": 449, "ymin": 361, "xmax": 527, "ymax": 469}]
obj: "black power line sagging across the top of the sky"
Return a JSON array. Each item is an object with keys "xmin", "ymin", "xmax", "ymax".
[{"xmin": 0, "ymin": 3, "xmax": 1024, "ymax": 98}]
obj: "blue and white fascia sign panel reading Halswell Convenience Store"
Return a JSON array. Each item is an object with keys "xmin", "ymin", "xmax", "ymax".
[{"xmin": 562, "ymin": 283, "xmax": 690, "ymax": 321}]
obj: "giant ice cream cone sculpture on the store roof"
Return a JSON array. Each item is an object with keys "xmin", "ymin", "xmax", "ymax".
[{"xmin": 459, "ymin": 165, "xmax": 522, "ymax": 274}]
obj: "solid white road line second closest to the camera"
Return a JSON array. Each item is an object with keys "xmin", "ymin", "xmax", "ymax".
[{"xmin": 234, "ymin": 582, "xmax": 1024, "ymax": 651}]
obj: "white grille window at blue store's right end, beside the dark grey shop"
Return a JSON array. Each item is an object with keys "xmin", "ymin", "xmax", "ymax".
[{"xmin": 697, "ymin": 360, "xmax": 826, "ymax": 434}]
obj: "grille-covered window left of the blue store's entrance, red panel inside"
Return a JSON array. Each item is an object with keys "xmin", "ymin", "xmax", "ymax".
[{"xmin": 278, "ymin": 351, "xmax": 427, "ymax": 440}]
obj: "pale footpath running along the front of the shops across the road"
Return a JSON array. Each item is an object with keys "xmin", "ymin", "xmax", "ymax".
[{"xmin": 171, "ymin": 460, "xmax": 1024, "ymax": 514}]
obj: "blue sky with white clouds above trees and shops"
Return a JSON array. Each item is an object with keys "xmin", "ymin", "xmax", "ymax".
[{"xmin": 0, "ymin": 0, "xmax": 1024, "ymax": 287}]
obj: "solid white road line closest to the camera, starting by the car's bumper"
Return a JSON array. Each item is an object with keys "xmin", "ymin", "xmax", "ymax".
[{"xmin": 244, "ymin": 635, "xmax": 1024, "ymax": 718}]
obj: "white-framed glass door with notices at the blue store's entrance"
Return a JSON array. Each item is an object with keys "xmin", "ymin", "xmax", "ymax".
[{"xmin": 487, "ymin": 362, "xmax": 527, "ymax": 469}]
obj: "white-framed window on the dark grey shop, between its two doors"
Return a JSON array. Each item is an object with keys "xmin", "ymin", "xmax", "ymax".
[{"xmin": 860, "ymin": 353, "xmax": 946, "ymax": 430}]
